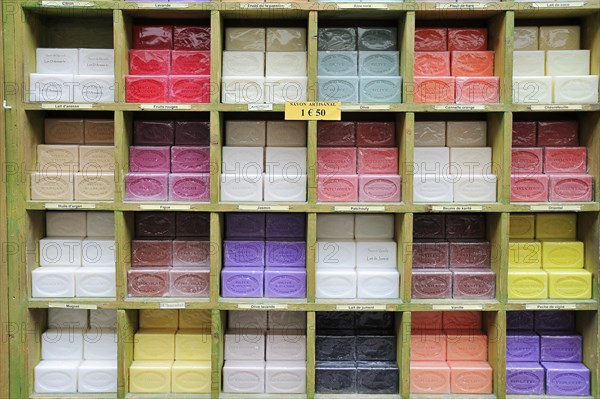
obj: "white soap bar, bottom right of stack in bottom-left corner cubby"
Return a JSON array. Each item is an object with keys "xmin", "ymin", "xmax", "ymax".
[{"xmin": 77, "ymin": 360, "xmax": 117, "ymax": 393}]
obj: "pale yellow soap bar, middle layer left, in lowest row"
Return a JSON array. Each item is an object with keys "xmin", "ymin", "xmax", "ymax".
[{"xmin": 133, "ymin": 329, "xmax": 175, "ymax": 360}]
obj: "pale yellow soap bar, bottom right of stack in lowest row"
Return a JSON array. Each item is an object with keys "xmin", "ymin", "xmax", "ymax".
[{"xmin": 171, "ymin": 360, "xmax": 210, "ymax": 393}]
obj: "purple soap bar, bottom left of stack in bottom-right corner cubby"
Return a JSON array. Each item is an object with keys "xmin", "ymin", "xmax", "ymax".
[{"xmin": 506, "ymin": 361, "xmax": 544, "ymax": 395}]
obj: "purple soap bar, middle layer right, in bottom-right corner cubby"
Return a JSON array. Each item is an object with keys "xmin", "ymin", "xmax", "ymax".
[{"xmin": 539, "ymin": 331, "xmax": 583, "ymax": 362}]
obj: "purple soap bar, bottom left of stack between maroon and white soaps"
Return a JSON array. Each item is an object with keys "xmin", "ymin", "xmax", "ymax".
[{"xmin": 221, "ymin": 267, "xmax": 264, "ymax": 298}]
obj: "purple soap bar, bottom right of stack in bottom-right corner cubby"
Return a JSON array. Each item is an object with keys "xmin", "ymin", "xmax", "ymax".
[{"xmin": 542, "ymin": 362, "xmax": 590, "ymax": 396}]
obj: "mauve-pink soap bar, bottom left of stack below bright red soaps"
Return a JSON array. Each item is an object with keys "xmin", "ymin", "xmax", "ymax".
[{"xmin": 125, "ymin": 173, "xmax": 169, "ymax": 201}]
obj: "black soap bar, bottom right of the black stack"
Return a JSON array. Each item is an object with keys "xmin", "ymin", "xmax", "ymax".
[{"xmin": 356, "ymin": 362, "xmax": 398, "ymax": 394}]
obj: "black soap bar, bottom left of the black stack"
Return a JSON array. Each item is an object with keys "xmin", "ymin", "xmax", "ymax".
[{"xmin": 315, "ymin": 362, "xmax": 356, "ymax": 393}]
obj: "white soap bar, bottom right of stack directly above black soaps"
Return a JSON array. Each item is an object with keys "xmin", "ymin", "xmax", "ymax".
[{"xmin": 356, "ymin": 269, "xmax": 400, "ymax": 299}]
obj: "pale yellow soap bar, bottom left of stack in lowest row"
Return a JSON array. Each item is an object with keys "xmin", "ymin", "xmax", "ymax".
[{"xmin": 129, "ymin": 361, "xmax": 173, "ymax": 393}]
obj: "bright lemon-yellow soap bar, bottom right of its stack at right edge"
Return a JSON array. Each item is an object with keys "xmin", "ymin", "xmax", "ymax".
[{"xmin": 548, "ymin": 269, "xmax": 592, "ymax": 299}]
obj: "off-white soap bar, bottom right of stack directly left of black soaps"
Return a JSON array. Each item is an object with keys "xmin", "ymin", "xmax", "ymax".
[{"xmin": 265, "ymin": 361, "xmax": 306, "ymax": 393}]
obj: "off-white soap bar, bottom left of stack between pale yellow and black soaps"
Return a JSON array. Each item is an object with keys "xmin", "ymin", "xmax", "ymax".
[{"xmin": 223, "ymin": 360, "xmax": 265, "ymax": 393}]
